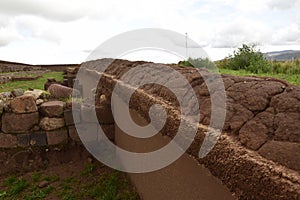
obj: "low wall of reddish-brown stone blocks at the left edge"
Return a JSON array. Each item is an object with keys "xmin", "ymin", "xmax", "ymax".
[{"xmin": 0, "ymin": 90, "xmax": 80, "ymax": 148}]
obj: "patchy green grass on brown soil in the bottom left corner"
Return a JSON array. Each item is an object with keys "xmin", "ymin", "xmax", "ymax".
[{"xmin": 0, "ymin": 163, "xmax": 140, "ymax": 200}]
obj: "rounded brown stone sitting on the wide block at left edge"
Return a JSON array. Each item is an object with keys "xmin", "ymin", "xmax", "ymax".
[{"xmin": 10, "ymin": 95, "xmax": 37, "ymax": 113}]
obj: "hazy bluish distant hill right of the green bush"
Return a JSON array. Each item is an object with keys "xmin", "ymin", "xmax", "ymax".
[{"xmin": 264, "ymin": 50, "xmax": 300, "ymax": 61}]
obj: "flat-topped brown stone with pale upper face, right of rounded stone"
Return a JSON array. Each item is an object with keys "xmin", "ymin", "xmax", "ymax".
[{"xmin": 40, "ymin": 101, "xmax": 64, "ymax": 117}]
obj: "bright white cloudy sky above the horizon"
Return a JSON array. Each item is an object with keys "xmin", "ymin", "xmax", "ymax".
[{"xmin": 0, "ymin": 0, "xmax": 300, "ymax": 64}]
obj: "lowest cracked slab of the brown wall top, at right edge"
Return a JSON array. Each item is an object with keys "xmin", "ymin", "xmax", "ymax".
[{"xmin": 258, "ymin": 141, "xmax": 300, "ymax": 171}]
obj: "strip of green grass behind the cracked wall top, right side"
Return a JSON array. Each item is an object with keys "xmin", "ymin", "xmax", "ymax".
[{"xmin": 219, "ymin": 68, "xmax": 300, "ymax": 86}]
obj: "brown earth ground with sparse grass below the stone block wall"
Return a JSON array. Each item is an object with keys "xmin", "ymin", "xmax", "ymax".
[{"xmin": 0, "ymin": 144, "xmax": 140, "ymax": 199}]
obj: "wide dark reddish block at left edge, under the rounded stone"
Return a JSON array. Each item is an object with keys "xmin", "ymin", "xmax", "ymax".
[{"xmin": 1, "ymin": 112, "xmax": 39, "ymax": 133}]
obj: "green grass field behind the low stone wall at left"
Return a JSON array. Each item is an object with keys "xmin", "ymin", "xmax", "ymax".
[{"xmin": 0, "ymin": 72, "xmax": 63, "ymax": 92}]
